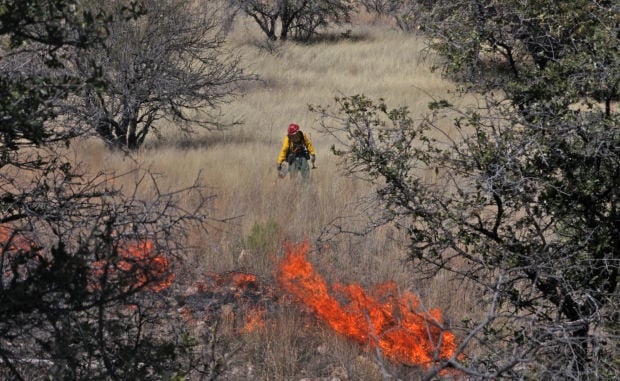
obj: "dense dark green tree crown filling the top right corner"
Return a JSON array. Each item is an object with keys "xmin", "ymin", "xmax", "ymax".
[{"xmin": 414, "ymin": 0, "xmax": 620, "ymax": 108}]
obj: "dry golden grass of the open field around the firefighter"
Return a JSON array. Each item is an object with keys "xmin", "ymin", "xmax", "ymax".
[{"xmin": 70, "ymin": 16, "xmax": 482, "ymax": 380}]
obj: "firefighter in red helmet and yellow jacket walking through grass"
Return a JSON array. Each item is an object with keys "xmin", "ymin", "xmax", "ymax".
[{"xmin": 277, "ymin": 123, "xmax": 316, "ymax": 182}]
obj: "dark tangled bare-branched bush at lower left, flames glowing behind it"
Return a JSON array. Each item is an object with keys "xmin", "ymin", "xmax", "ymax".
[{"xmin": 0, "ymin": 148, "xmax": 220, "ymax": 379}]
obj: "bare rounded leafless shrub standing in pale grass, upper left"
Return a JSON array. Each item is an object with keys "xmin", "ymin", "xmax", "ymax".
[{"xmin": 62, "ymin": 0, "xmax": 253, "ymax": 149}]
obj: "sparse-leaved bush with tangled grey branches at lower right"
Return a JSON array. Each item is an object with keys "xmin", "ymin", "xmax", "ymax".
[{"xmin": 317, "ymin": 96, "xmax": 620, "ymax": 380}]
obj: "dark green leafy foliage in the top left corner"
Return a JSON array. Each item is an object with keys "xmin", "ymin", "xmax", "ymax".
[{"xmin": 0, "ymin": 0, "xmax": 105, "ymax": 160}]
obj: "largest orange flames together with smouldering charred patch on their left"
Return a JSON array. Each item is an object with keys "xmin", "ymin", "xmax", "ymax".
[{"xmin": 173, "ymin": 242, "xmax": 456, "ymax": 376}]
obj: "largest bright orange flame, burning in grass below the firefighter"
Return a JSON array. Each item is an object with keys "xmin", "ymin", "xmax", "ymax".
[{"xmin": 276, "ymin": 242, "xmax": 456, "ymax": 367}]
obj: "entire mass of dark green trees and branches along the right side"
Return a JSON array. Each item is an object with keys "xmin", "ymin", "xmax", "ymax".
[{"xmin": 317, "ymin": 0, "xmax": 620, "ymax": 379}]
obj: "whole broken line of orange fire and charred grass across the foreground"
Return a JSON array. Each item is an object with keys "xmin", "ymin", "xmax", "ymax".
[{"xmin": 0, "ymin": 220, "xmax": 456, "ymax": 377}]
